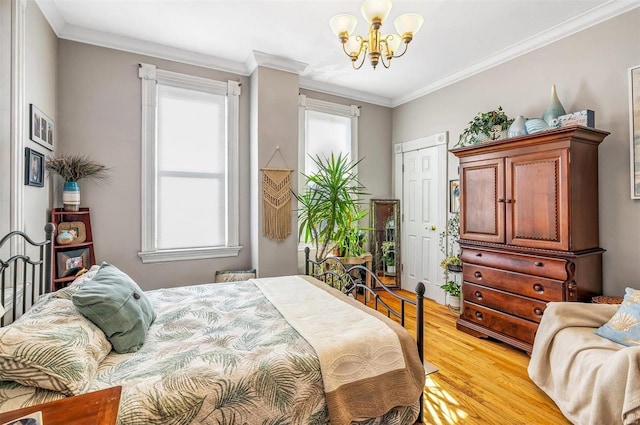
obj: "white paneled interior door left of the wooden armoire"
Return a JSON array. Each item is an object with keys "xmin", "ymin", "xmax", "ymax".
[{"xmin": 401, "ymin": 139, "xmax": 447, "ymax": 303}]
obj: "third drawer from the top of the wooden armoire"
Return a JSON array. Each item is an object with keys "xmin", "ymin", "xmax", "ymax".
[{"xmin": 462, "ymin": 282, "xmax": 547, "ymax": 323}]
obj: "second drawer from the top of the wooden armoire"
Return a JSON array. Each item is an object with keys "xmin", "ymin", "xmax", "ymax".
[{"xmin": 462, "ymin": 263, "xmax": 564, "ymax": 301}]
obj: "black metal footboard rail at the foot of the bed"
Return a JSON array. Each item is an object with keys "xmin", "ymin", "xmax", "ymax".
[{"xmin": 304, "ymin": 247, "xmax": 425, "ymax": 423}]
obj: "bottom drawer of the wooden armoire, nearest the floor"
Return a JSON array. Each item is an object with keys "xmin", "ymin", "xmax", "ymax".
[{"xmin": 462, "ymin": 302, "xmax": 538, "ymax": 344}]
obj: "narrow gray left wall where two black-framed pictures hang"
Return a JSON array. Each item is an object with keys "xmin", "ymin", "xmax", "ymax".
[{"xmin": 20, "ymin": 2, "xmax": 59, "ymax": 240}]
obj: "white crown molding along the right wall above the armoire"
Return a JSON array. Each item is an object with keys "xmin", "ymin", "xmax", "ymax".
[{"xmin": 391, "ymin": 0, "xmax": 640, "ymax": 107}]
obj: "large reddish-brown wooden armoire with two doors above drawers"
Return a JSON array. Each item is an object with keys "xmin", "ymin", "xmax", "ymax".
[{"xmin": 451, "ymin": 126, "xmax": 609, "ymax": 352}]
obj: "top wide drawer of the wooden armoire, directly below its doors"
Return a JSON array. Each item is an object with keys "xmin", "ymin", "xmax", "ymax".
[{"xmin": 462, "ymin": 248, "xmax": 568, "ymax": 281}]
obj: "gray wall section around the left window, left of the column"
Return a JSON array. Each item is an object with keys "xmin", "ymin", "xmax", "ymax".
[{"xmin": 55, "ymin": 40, "xmax": 251, "ymax": 289}]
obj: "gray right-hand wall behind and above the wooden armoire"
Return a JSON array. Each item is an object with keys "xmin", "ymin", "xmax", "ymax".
[{"xmin": 393, "ymin": 9, "xmax": 640, "ymax": 295}]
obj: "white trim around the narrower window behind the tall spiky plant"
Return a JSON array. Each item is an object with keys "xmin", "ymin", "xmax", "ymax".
[{"xmin": 298, "ymin": 94, "xmax": 360, "ymax": 193}]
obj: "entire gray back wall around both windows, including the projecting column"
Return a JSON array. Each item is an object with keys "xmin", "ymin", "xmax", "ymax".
[{"xmin": 54, "ymin": 40, "xmax": 391, "ymax": 289}]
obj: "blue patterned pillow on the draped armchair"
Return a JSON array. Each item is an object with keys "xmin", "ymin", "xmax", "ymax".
[{"xmin": 595, "ymin": 288, "xmax": 640, "ymax": 347}]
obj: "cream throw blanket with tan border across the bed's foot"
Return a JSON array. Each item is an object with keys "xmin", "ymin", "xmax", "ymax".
[{"xmin": 251, "ymin": 276, "xmax": 425, "ymax": 425}]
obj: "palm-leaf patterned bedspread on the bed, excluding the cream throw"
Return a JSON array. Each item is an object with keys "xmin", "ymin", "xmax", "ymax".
[{"xmin": 0, "ymin": 282, "xmax": 418, "ymax": 425}]
